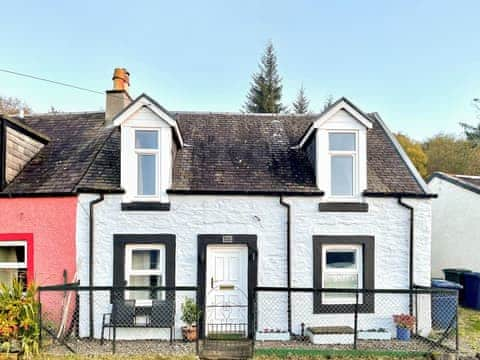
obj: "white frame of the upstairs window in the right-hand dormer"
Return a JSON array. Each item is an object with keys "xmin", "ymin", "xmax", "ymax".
[{"xmin": 327, "ymin": 130, "xmax": 359, "ymax": 200}]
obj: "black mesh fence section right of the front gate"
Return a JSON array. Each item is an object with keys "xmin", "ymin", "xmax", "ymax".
[{"xmin": 255, "ymin": 287, "xmax": 459, "ymax": 355}]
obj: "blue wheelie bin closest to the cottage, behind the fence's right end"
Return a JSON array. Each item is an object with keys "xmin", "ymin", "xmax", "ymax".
[{"xmin": 432, "ymin": 279, "xmax": 462, "ymax": 330}]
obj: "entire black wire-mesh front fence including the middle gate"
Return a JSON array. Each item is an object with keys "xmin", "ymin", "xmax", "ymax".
[{"xmin": 35, "ymin": 284, "xmax": 459, "ymax": 356}]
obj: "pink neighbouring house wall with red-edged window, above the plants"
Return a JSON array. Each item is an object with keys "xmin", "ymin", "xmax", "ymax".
[{"xmin": 0, "ymin": 196, "xmax": 77, "ymax": 285}]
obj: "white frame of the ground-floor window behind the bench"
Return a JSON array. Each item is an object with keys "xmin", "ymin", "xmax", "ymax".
[{"xmin": 125, "ymin": 244, "xmax": 167, "ymax": 306}]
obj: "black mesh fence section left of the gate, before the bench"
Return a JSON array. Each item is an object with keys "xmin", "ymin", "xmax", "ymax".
[{"xmin": 38, "ymin": 284, "xmax": 197, "ymax": 355}]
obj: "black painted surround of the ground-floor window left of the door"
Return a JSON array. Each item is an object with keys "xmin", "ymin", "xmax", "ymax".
[{"xmin": 113, "ymin": 234, "xmax": 176, "ymax": 313}]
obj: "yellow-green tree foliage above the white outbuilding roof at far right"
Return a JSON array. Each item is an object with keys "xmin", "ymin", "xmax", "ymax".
[{"xmin": 423, "ymin": 134, "xmax": 480, "ymax": 175}]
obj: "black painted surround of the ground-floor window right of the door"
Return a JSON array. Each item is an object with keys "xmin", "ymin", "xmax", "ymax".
[{"xmin": 313, "ymin": 235, "xmax": 375, "ymax": 314}]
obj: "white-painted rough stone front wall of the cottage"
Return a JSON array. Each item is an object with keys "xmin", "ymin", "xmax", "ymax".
[{"xmin": 77, "ymin": 194, "xmax": 431, "ymax": 338}]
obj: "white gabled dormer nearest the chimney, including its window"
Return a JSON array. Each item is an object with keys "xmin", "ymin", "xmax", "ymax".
[{"xmin": 113, "ymin": 95, "xmax": 183, "ymax": 202}]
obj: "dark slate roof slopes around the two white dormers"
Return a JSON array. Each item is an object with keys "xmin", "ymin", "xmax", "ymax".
[{"xmin": 0, "ymin": 108, "xmax": 425, "ymax": 195}]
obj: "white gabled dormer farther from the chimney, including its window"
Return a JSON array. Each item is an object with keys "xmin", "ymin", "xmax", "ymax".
[{"xmin": 298, "ymin": 99, "xmax": 372, "ymax": 201}]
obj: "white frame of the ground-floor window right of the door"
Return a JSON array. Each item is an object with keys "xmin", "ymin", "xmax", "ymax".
[{"xmin": 322, "ymin": 244, "xmax": 363, "ymax": 304}]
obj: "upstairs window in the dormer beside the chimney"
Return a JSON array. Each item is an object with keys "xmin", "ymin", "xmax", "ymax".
[{"xmin": 135, "ymin": 130, "xmax": 160, "ymax": 197}]
